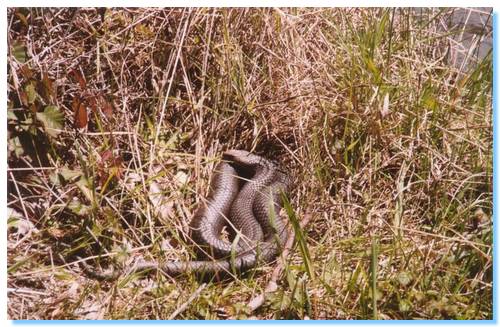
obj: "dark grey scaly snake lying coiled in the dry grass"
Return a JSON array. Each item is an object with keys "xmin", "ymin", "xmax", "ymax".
[{"xmin": 82, "ymin": 150, "xmax": 290, "ymax": 280}]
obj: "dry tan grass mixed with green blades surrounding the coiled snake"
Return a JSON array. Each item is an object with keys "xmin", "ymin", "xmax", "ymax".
[{"xmin": 7, "ymin": 8, "xmax": 492, "ymax": 319}]
